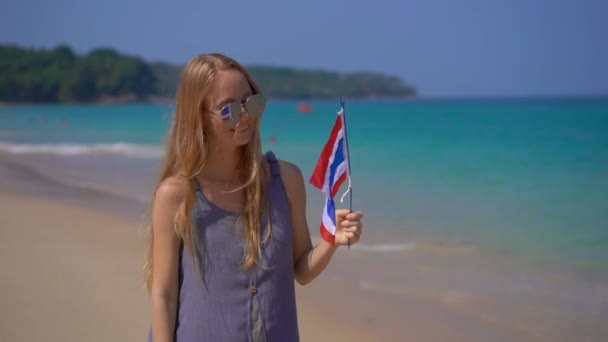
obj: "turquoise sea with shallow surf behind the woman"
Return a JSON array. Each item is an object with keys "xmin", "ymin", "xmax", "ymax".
[{"xmin": 0, "ymin": 99, "xmax": 608, "ymax": 278}]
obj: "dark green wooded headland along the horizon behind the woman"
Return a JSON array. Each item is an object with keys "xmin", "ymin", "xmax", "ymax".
[{"xmin": 0, "ymin": 45, "xmax": 416, "ymax": 102}]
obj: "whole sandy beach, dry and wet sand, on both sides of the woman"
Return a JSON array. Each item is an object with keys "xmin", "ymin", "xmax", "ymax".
[{"xmin": 0, "ymin": 154, "xmax": 608, "ymax": 341}]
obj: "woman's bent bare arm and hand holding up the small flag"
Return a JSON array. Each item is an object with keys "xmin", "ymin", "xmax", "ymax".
[{"xmin": 280, "ymin": 161, "xmax": 361, "ymax": 285}]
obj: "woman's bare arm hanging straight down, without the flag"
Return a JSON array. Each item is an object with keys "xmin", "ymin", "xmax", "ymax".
[{"xmin": 150, "ymin": 178, "xmax": 185, "ymax": 342}]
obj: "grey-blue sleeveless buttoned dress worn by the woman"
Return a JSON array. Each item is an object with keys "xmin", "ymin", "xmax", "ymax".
[{"xmin": 148, "ymin": 152, "xmax": 299, "ymax": 342}]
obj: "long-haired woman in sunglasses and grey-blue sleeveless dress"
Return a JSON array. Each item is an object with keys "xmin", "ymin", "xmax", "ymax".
[{"xmin": 146, "ymin": 54, "xmax": 362, "ymax": 342}]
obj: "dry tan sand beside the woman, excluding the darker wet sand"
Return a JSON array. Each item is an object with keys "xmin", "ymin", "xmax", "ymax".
[{"xmin": 0, "ymin": 193, "xmax": 382, "ymax": 341}]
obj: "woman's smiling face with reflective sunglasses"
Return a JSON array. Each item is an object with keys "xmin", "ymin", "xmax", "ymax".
[{"xmin": 207, "ymin": 69, "xmax": 266, "ymax": 150}]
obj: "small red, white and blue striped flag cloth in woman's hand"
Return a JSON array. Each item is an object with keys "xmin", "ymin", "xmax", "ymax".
[{"xmin": 310, "ymin": 106, "xmax": 349, "ymax": 244}]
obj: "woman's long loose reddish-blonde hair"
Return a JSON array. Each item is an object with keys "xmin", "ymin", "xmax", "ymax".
[{"xmin": 144, "ymin": 53, "xmax": 268, "ymax": 292}]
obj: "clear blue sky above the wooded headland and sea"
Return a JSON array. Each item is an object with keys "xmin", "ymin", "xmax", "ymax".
[{"xmin": 0, "ymin": 0, "xmax": 608, "ymax": 97}]
